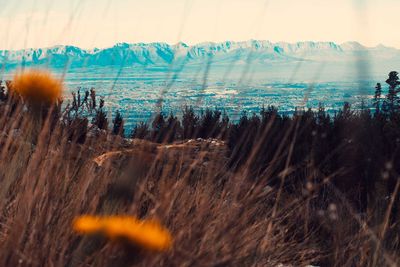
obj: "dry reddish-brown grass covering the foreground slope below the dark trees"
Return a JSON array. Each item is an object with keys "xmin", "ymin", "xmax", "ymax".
[{"xmin": 0, "ymin": 97, "xmax": 400, "ymax": 266}]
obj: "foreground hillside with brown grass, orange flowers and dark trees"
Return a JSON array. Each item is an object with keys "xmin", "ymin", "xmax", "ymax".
[{"xmin": 0, "ymin": 70, "xmax": 400, "ymax": 267}]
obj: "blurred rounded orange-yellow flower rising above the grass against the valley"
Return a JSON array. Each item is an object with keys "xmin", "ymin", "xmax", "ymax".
[{"xmin": 11, "ymin": 70, "xmax": 63, "ymax": 104}]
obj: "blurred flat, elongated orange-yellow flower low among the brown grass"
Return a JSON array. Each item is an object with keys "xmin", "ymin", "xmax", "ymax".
[{"xmin": 73, "ymin": 216, "xmax": 172, "ymax": 251}]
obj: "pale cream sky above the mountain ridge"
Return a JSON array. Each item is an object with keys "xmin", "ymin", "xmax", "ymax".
[{"xmin": 0, "ymin": 0, "xmax": 400, "ymax": 50}]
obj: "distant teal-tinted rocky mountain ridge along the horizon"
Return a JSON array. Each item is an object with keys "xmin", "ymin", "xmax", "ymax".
[{"xmin": 0, "ymin": 40, "xmax": 400, "ymax": 67}]
